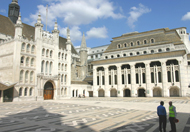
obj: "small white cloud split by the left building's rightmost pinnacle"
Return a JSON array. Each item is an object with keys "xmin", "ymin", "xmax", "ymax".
[{"xmin": 60, "ymin": 26, "xmax": 82, "ymax": 42}]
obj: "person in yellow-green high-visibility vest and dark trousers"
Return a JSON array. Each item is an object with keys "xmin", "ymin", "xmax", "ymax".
[{"xmin": 169, "ymin": 101, "xmax": 177, "ymax": 132}]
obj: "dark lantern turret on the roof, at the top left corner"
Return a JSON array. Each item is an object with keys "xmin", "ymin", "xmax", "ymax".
[{"xmin": 8, "ymin": 0, "xmax": 20, "ymax": 24}]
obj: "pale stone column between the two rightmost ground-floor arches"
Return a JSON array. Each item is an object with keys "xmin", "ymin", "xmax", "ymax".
[{"xmin": 161, "ymin": 61, "xmax": 169, "ymax": 97}]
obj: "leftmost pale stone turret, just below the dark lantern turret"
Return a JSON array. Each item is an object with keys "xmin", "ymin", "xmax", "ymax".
[{"xmin": 15, "ymin": 14, "xmax": 23, "ymax": 39}]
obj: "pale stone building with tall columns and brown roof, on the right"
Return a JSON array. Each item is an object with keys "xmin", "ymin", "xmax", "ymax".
[{"xmin": 92, "ymin": 27, "xmax": 190, "ymax": 97}]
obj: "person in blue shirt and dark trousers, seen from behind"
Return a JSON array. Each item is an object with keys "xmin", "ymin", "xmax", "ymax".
[{"xmin": 157, "ymin": 101, "xmax": 166, "ymax": 132}]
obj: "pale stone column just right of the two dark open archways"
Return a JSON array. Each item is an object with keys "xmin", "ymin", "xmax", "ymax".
[{"xmin": 145, "ymin": 62, "xmax": 153, "ymax": 97}]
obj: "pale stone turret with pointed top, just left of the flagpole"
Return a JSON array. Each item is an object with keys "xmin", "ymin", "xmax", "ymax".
[{"xmin": 35, "ymin": 13, "xmax": 43, "ymax": 40}]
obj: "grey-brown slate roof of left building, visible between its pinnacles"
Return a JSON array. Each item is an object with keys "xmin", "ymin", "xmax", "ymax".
[{"xmin": 0, "ymin": 15, "xmax": 78, "ymax": 54}]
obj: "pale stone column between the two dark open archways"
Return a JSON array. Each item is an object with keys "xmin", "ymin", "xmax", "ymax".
[{"xmin": 130, "ymin": 64, "xmax": 136, "ymax": 97}]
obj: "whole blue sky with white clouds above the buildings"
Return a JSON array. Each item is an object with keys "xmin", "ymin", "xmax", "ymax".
[{"xmin": 0, "ymin": 0, "xmax": 190, "ymax": 47}]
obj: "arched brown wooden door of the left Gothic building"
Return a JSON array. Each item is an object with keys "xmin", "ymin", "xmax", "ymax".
[{"xmin": 44, "ymin": 82, "xmax": 54, "ymax": 100}]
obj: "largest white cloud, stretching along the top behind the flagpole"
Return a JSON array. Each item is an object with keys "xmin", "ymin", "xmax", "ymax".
[{"xmin": 23, "ymin": 0, "xmax": 125, "ymax": 27}]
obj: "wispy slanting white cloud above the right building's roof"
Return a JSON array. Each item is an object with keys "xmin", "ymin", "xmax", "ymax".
[{"xmin": 127, "ymin": 4, "xmax": 151, "ymax": 29}]
